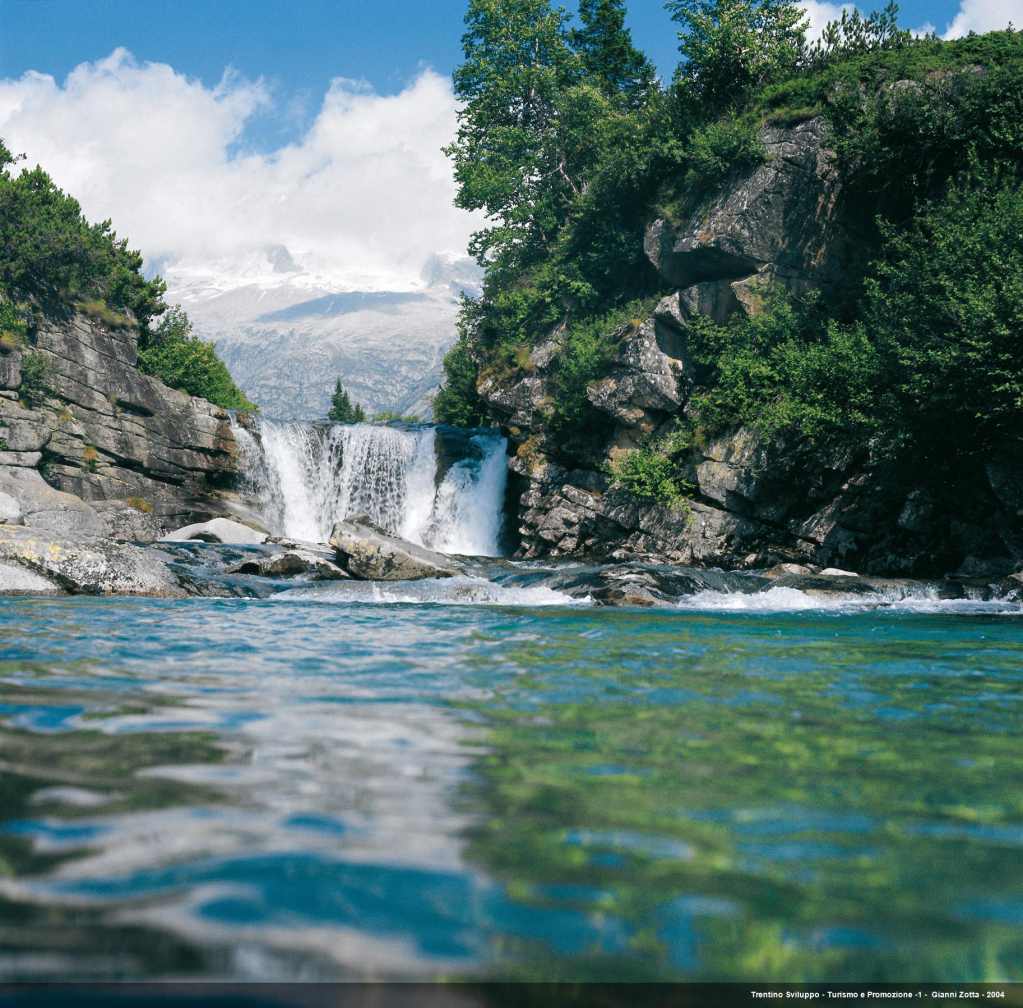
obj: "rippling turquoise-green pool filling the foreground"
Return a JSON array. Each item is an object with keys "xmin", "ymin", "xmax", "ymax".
[{"xmin": 0, "ymin": 591, "xmax": 1023, "ymax": 981}]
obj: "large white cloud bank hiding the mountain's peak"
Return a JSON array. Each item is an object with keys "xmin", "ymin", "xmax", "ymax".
[{"xmin": 0, "ymin": 49, "xmax": 479, "ymax": 282}]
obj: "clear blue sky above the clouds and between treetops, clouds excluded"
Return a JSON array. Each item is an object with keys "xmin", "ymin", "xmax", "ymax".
[{"xmin": 0, "ymin": 0, "xmax": 996, "ymax": 107}]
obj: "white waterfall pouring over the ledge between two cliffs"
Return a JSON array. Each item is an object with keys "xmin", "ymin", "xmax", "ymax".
[{"xmin": 234, "ymin": 417, "xmax": 507, "ymax": 557}]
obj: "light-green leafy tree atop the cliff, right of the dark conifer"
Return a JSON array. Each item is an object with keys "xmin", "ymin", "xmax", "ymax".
[{"xmin": 666, "ymin": 0, "xmax": 807, "ymax": 114}]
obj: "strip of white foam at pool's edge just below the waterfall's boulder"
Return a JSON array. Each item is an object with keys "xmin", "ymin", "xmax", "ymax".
[{"xmin": 273, "ymin": 574, "xmax": 590, "ymax": 606}]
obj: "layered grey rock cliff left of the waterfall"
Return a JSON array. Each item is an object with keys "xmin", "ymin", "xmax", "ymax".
[{"xmin": 0, "ymin": 300, "xmax": 245, "ymax": 541}]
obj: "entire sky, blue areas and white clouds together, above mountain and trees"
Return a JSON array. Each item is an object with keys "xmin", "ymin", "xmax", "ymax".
[{"xmin": 0, "ymin": 0, "xmax": 1010, "ymax": 288}]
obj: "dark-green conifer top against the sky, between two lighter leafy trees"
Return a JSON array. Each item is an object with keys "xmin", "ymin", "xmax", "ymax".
[{"xmin": 569, "ymin": 0, "xmax": 656, "ymax": 108}]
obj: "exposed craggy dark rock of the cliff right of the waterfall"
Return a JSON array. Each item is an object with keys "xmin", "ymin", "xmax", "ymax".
[{"xmin": 474, "ymin": 118, "xmax": 1023, "ymax": 576}]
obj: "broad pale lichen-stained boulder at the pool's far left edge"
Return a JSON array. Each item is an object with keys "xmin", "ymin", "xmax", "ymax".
[{"xmin": 0, "ymin": 525, "xmax": 187, "ymax": 599}]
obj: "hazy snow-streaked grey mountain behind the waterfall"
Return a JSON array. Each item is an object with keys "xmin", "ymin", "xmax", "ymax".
[{"xmin": 163, "ymin": 246, "xmax": 482, "ymax": 420}]
